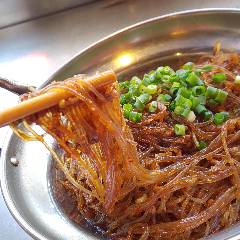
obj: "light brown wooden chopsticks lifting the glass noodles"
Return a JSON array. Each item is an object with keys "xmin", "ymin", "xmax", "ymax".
[{"xmin": 0, "ymin": 71, "xmax": 117, "ymax": 127}]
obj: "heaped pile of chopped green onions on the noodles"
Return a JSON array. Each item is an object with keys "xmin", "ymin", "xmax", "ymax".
[{"xmin": 119, "ymin": 62, "xmax": 232, "ymax": 125}]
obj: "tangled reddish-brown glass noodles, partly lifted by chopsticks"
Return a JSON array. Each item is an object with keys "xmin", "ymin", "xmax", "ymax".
[{"xmin": 12, "ymin": 45, "xmax": 240, "ymax": 240}]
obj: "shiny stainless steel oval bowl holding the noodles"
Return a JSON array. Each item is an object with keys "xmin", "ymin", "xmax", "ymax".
[{"xmin": 1, "ymin": 9, "xmax": 240, "ymax": 240}]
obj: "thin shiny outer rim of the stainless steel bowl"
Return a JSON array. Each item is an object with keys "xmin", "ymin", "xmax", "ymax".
[{"xmin": 0, "ymin": 8, "xmax": 240, "ymax": 240}]
